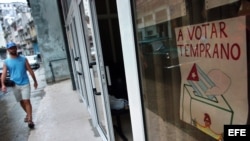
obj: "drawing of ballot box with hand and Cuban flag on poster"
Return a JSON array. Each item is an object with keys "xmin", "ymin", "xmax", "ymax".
[{"xmin": 180, "ymin": 64, "xmax": 234, "ymax": 138}]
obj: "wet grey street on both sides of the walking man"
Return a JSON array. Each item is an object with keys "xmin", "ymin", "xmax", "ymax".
[{"xmin": 0, "ymin": 64, "xmax": 47, "ymax": 141}]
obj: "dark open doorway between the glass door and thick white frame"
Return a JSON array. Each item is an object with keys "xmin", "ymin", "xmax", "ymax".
[{"xmin": 95, "ymin": 0, "xmax": 133, "ymax": 140}]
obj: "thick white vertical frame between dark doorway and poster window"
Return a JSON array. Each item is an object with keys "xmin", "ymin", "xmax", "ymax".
[{"xmin": 116, "ymin": 0, "xmax": 146, "ymax": 141}]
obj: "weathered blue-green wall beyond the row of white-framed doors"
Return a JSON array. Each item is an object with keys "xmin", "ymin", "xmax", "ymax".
[{"xmin": 29, "ymin": 0, "xmax": 70, "ymax": 82}]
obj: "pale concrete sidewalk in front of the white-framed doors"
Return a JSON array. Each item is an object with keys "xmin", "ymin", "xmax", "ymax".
[{"xmin": 28, "ymin": 80, "xmax": 102, "ymax": 141}]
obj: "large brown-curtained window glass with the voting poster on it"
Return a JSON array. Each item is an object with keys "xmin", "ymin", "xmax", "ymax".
[{"xmin": 134, "ymin": 0, "xmax": 250, "ymax": 141}]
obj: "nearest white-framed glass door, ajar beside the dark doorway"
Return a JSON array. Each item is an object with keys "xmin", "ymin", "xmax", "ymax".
[{"xmin": 79, "ymin": 1, "xmax": 114, "ymax": 141}]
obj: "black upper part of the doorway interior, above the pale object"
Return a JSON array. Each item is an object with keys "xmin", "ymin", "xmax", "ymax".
[{"xmin": 96, "ymin": 0, "xmax": 128, "ymax": 99}]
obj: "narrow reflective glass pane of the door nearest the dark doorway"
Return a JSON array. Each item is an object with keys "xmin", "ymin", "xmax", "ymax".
[{"xmin": 80, "ymin": 2, "xmax": 107, "ymax": 135}]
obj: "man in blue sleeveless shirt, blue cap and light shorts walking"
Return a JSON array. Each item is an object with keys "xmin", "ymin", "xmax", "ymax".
[{"xmin": 1, "ymin": 42, "xmax": 38, "ymax": 128}]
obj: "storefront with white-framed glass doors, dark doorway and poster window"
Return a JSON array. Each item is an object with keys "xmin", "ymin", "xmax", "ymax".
[{"xmin": 29, "ymin": 0, "xmax": 250, "ymax": 141}]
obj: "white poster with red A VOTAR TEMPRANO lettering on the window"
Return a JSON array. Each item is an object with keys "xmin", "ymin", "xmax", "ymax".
[{"xmin": 175, "ymin": 16, "xmax": 248, "ymax": 140}]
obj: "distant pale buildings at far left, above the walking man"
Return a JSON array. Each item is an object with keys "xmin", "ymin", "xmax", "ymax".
[{"xmin": 0, "ymin": 2, "xmax": 40, "ymax": 55}]
